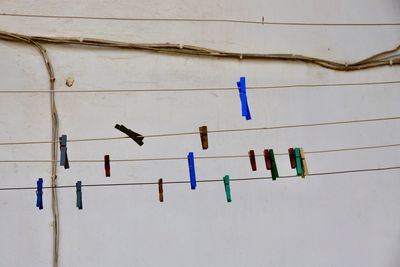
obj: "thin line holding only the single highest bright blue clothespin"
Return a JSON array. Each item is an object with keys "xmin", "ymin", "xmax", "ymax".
[{"xmin": 0, "ymin": 80, "xmax": 400, "ymax": 94}]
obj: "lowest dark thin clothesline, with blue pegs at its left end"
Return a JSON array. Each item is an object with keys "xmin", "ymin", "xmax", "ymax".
[{"xmin": 0, "ymin": 166, "xmax": 400, "ymax": 191}]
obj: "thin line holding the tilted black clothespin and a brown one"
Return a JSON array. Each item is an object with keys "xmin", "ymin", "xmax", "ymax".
[{"xmin": 0, "ymin": 116, "xmax": 400, "ymax": 146}]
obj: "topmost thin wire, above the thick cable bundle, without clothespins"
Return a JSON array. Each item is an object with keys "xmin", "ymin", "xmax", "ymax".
[{"xmin": 0, "ymin": 13, "xmax": 400, "ymax": 26}]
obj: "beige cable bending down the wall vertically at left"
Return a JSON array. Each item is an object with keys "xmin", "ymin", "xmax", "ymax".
[{"xmin": 0, "ymin": 29, "xmax": 60, "ymax": 267}]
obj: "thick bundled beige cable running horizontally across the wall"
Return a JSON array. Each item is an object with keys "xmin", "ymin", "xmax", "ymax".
[{"xmin": 0, "ymin": 31, "xmax": 400, "ymax": 71}]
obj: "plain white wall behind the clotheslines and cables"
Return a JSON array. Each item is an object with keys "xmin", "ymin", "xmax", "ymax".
[{"xmin": 0, "ymin": 0, "xmax": 400, "ymax": 267}]
